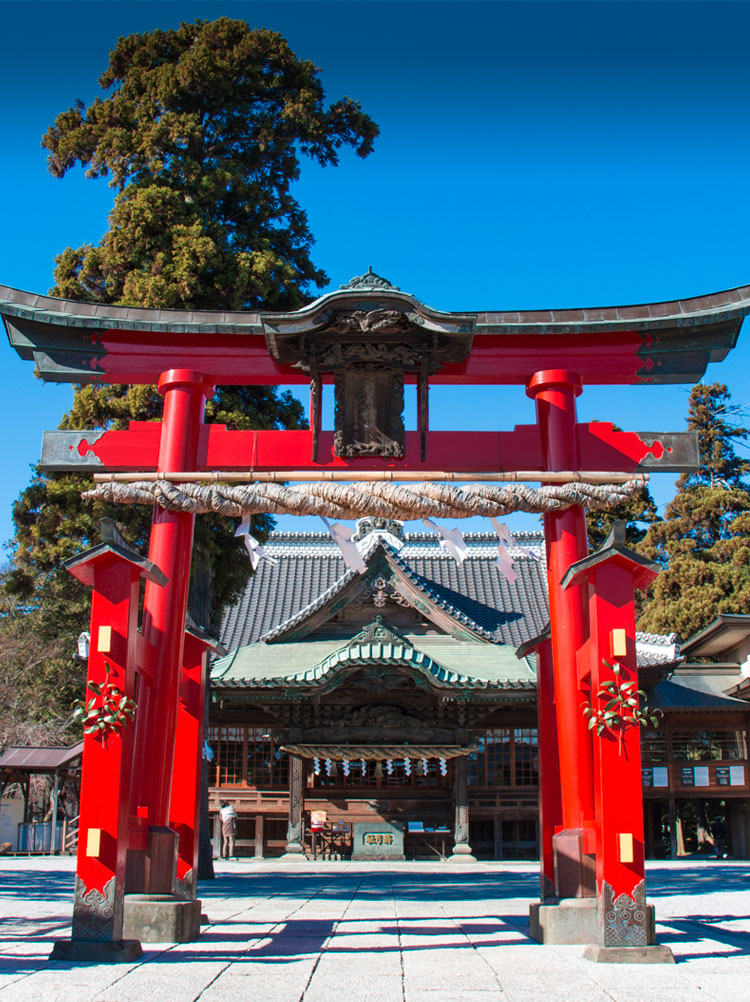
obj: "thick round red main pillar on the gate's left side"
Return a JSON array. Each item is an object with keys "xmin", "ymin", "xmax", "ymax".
[{"xmin": 131, "ymin": 369, "xmax": 213, "ymax": 893}]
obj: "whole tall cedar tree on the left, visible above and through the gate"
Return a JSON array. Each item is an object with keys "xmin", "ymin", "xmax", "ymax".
[{"xmin": 5, "ymin": 18, "xmax": 378, "ymax": 737}]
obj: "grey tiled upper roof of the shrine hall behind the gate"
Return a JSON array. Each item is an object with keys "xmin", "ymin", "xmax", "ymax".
[{"xmin": 220, "ymin": 532, "xmax": 549, "ymax": 651}]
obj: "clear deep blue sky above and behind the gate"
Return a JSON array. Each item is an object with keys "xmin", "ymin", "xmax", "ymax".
[{"xmin": 0, "ymin": 0, "xmax": 750, "ymax": 539}]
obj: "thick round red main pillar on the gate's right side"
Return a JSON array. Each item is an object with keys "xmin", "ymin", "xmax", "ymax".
[{"xmin": 527, "ymin": 369, "xmax": 595, "ymax": 898}]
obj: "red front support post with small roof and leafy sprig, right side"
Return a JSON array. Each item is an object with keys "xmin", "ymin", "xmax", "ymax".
[{"xmin": 563, "ymin": 522, "xmax": 671, "ymax": 961}]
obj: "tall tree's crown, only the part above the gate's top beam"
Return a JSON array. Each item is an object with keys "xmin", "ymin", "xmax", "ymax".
[{"xmin": 42, "ymin": 17, "xmax": 378, "ymax": 310}]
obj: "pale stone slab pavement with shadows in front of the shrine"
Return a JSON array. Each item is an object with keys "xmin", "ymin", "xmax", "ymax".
[{"xmin": 0, "ymin": 858, "xmax": 750, "ymax": 1002}]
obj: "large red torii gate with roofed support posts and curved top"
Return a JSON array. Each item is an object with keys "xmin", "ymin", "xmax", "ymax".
[{"xmin": 0, "ymin": 271, "xmax": 750, "ymax": 961}]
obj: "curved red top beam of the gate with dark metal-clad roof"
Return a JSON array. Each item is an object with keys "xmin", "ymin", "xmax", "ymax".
[{"xmin": 0, "ymin": 271, "xmax": 750, "ymax": 385}]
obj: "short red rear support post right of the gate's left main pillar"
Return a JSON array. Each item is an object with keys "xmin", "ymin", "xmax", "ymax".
[{"xmin": 169, "ymin": 628, "xmax": 223, "ymax": 901}]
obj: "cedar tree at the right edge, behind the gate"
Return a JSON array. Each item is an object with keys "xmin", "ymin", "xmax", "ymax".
[{"xmin": 638, "ymin": 383, "xmax": 750, "ymax": 638}]
